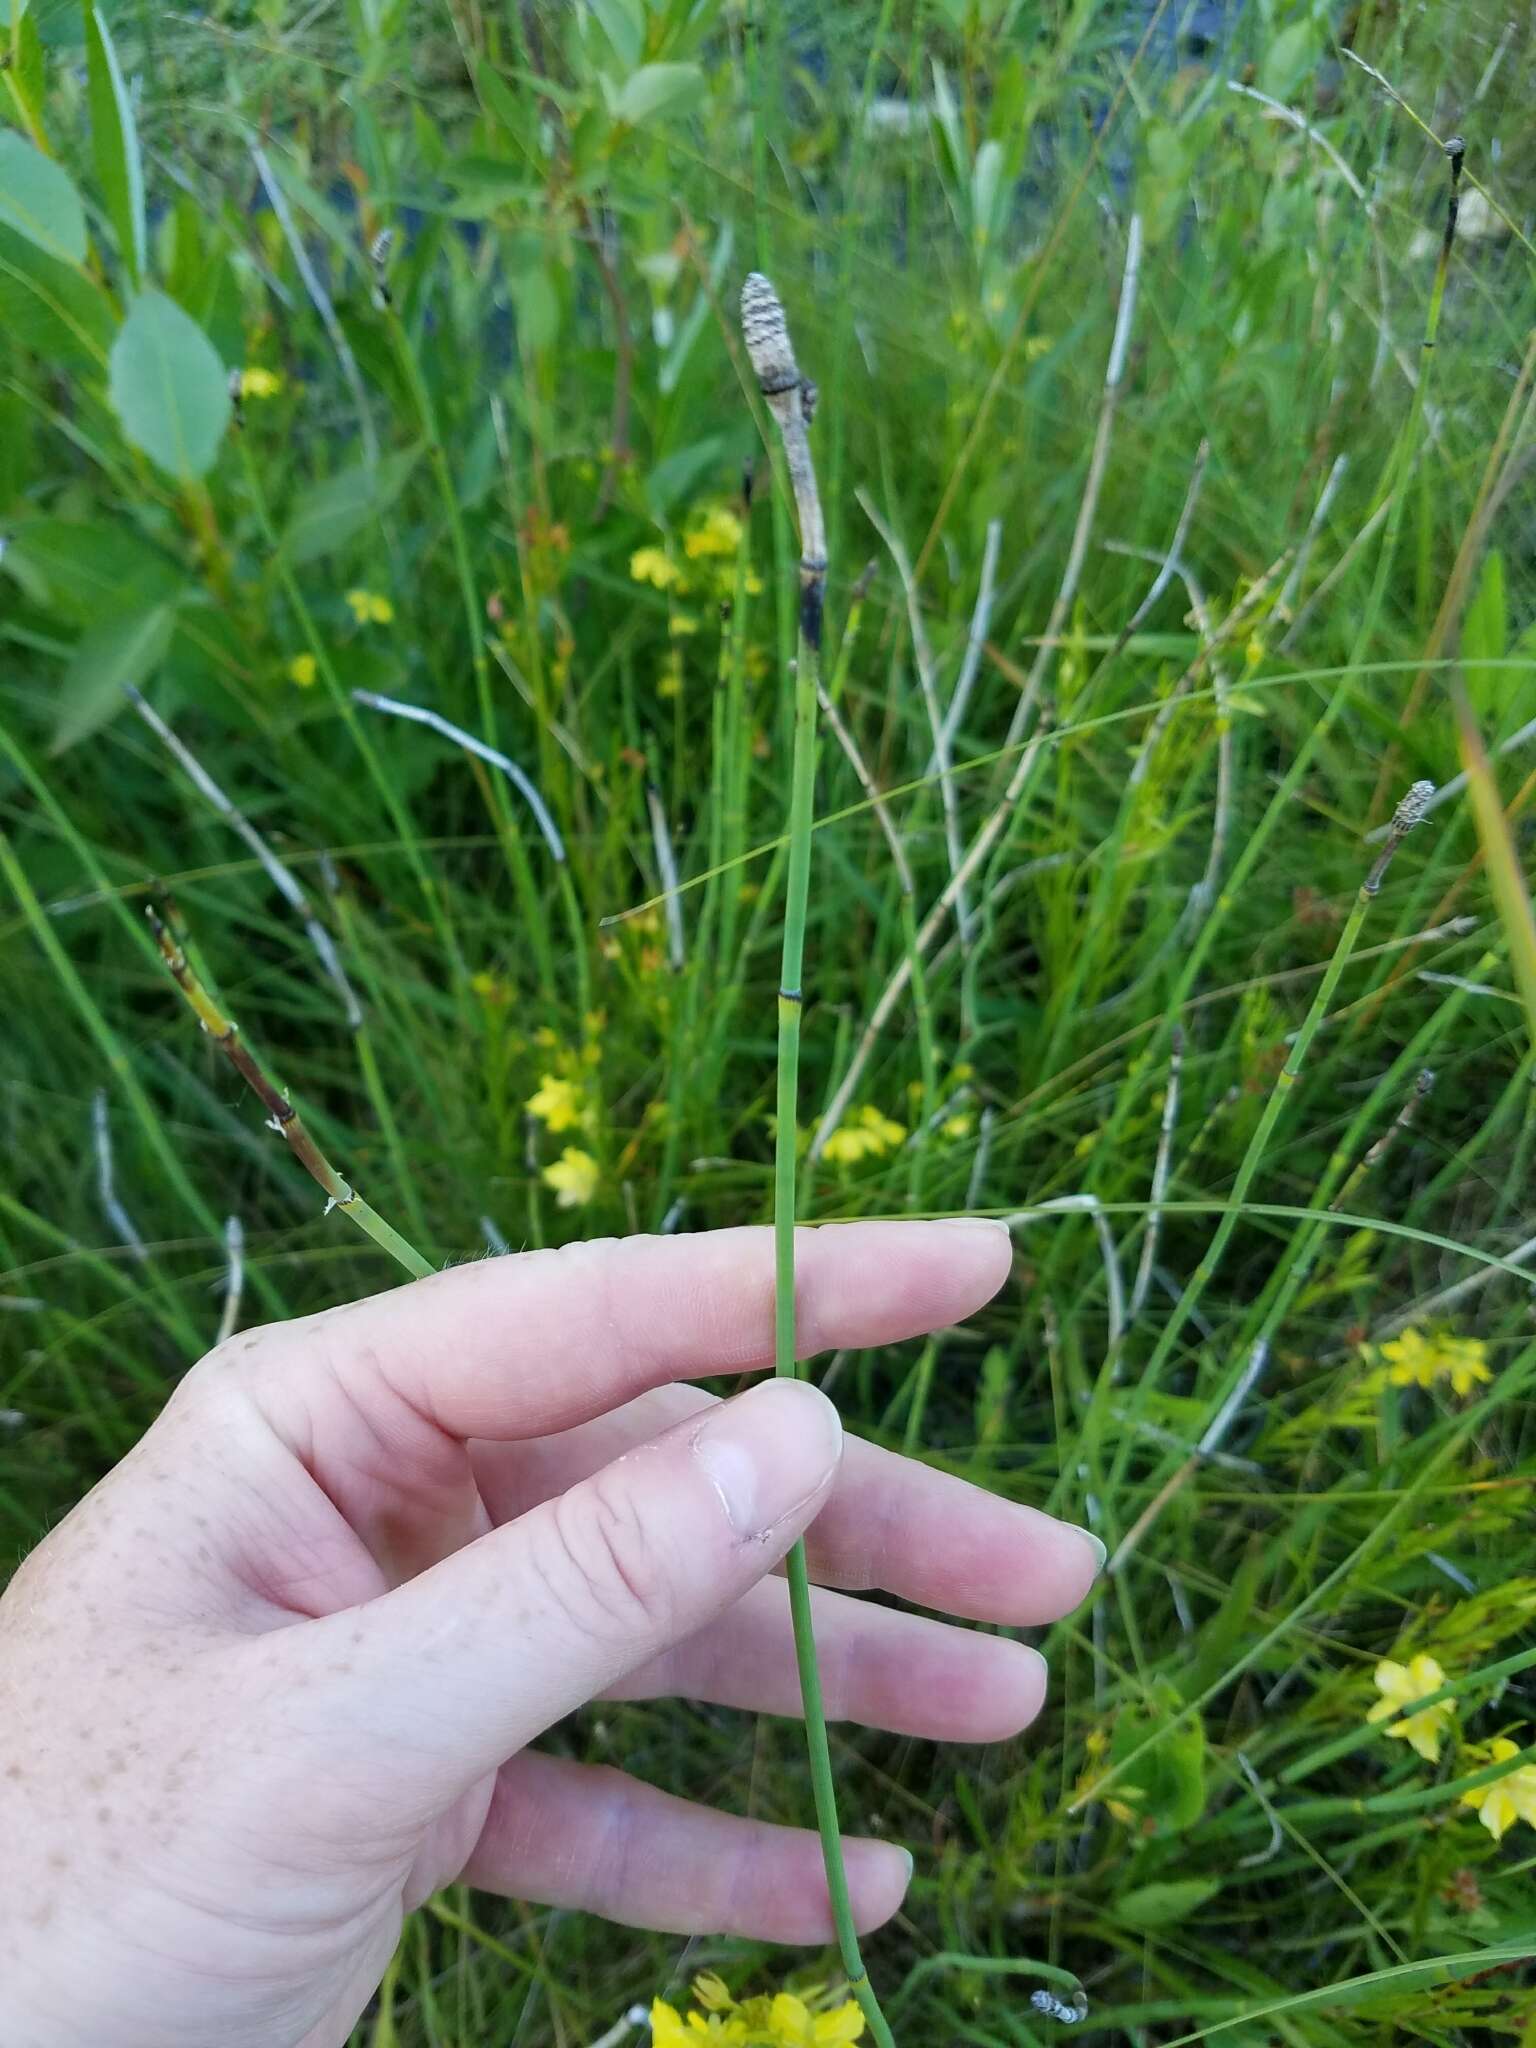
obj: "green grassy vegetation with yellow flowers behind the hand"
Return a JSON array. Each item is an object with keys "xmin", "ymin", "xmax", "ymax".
[{"xmin": 0, "ymin": 0, "xmax": 1536, "ymax": 2048}]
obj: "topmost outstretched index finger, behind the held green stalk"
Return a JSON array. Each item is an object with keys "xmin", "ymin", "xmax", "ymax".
[{"xmin": 262, "ymin": 1219, "xmax": 1012, "ymax": 1440}]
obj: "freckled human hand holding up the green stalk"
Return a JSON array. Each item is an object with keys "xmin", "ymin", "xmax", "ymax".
[{"xmin": 0, "ymin": 1223, "xmax": 1098, "ymax": 2048}]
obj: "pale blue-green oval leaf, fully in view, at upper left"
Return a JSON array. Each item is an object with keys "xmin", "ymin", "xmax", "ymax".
[{"xmin": 111, "ymin": 291, "xmax": 229, "ymax": 483}]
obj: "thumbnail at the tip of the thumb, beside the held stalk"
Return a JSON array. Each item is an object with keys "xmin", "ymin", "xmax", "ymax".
[{"xmin": 692, "ymin": 1380, "xmax": 842, "ymax": 1538}]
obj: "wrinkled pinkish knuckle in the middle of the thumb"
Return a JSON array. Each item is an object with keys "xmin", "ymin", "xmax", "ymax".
[{"xmin": 543, "ymin": 1473, "xmax": 676, "ymax": 1647}]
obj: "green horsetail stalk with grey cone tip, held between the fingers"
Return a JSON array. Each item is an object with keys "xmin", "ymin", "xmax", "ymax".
[{"xmin": 741, "ymin": 272, "xmax": 895, "ymax": 2048}]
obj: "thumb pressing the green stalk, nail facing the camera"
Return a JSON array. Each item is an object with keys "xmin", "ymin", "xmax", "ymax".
[{"xmin": 288, "ymin": 1380, "xmax": 842, "ymax": 1804}]
